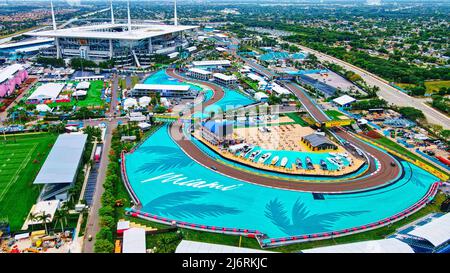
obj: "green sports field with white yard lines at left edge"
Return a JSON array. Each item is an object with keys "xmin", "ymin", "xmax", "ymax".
[{"xmin": 0, "ymin": 133, "xmax": 57, "ymax": 231}]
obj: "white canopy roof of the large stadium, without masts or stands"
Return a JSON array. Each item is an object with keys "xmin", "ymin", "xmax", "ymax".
[{"xmin": 26, "ymin": 23, "xmax": 198, "ymax": 40}]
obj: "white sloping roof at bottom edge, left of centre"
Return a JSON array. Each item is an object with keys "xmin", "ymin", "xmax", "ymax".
[{"xmin": 175, "ymin": 240, "xmax": 271, "ymax": 253}]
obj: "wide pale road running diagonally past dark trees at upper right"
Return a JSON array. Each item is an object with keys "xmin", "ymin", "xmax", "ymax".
[{"xmin": 284, "ymin": 40, "xmax": 450, "ymax": 129}]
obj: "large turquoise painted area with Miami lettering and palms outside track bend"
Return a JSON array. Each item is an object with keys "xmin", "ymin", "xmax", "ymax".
[{"xmin": 125, "ymin": 127, "xmax": 438, "ymax": 238}]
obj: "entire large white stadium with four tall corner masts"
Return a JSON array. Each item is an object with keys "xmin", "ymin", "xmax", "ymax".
[{"xmin": 26, "ymin": 1, "xmax": 197, "ymax": 66}]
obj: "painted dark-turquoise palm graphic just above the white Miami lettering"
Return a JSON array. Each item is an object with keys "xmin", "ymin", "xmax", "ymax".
[{"xmin": 137, "ymin": 146, "xmax": 193, "ymax": 173}]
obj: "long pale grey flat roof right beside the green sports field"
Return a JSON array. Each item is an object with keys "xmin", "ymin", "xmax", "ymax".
[{"xmin": 33, "ymin": 134, "xmax": 87, "ymax": 184}]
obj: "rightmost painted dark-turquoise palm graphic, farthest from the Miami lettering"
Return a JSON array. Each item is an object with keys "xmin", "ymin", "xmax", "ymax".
[{"xmin": 265, "ymin": 198, "xmax": 368, "ymax": 235}]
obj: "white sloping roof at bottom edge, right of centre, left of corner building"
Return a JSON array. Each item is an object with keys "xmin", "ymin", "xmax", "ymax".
[{"xmin": 302, "ymin": 238, "xmax": 414, "ymax": 253}]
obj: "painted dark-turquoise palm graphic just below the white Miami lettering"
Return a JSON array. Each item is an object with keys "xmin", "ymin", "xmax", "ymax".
[{"xmin": 143, "ymin": 191, "xmax": 241, "ymax": 219}]
